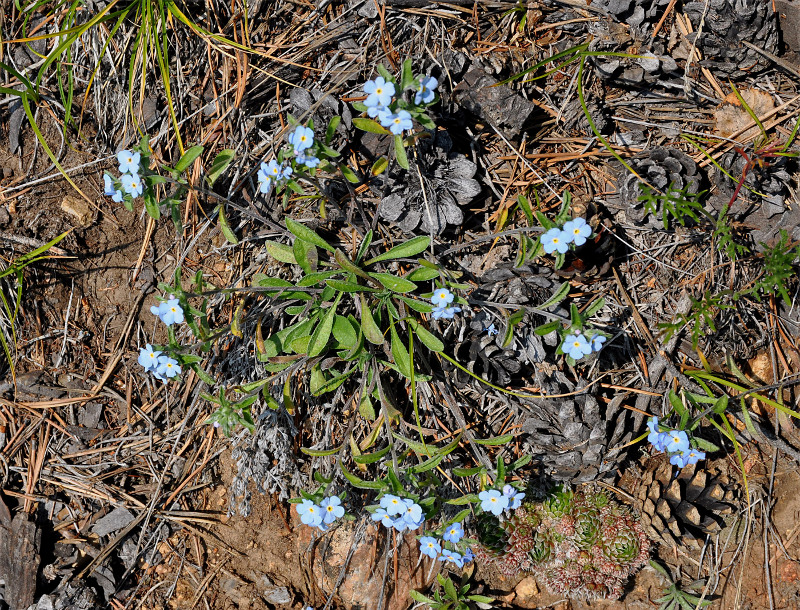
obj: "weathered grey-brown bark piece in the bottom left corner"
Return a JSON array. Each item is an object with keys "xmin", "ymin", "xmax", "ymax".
[{"xmin": 0, "ymin": 499, "xmax": 41, "ymax": 610}]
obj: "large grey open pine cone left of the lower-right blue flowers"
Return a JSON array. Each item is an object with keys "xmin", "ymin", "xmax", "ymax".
[{"xmin": 521, "ymin": 368, "xmax": 642, "ymax": 483}]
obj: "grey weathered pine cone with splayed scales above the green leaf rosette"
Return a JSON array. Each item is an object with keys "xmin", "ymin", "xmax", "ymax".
[{"xmin": 378, "ymin": 131, "xmax": 481, "ymax": 235}]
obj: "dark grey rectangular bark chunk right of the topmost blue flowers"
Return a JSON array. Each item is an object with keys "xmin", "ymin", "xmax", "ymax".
[{"xmin": 453, "ymin": 66, "xmax": 536, "ymax": 138}]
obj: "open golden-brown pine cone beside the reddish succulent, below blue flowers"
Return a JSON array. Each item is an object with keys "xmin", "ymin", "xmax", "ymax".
[{"xmin": 620, "ymin": 454, "xmax": 736, "ymax": 553}]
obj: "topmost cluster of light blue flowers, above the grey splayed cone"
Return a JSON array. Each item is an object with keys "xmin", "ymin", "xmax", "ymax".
[{"xmin": 364, "ymin": 76, "xmax": 439, "ymax": 136}]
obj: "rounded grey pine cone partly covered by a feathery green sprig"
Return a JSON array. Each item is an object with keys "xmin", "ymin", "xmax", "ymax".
[{"xmin": 608, "ymin": 146, "xmax": 702, "ymax": 229}]
